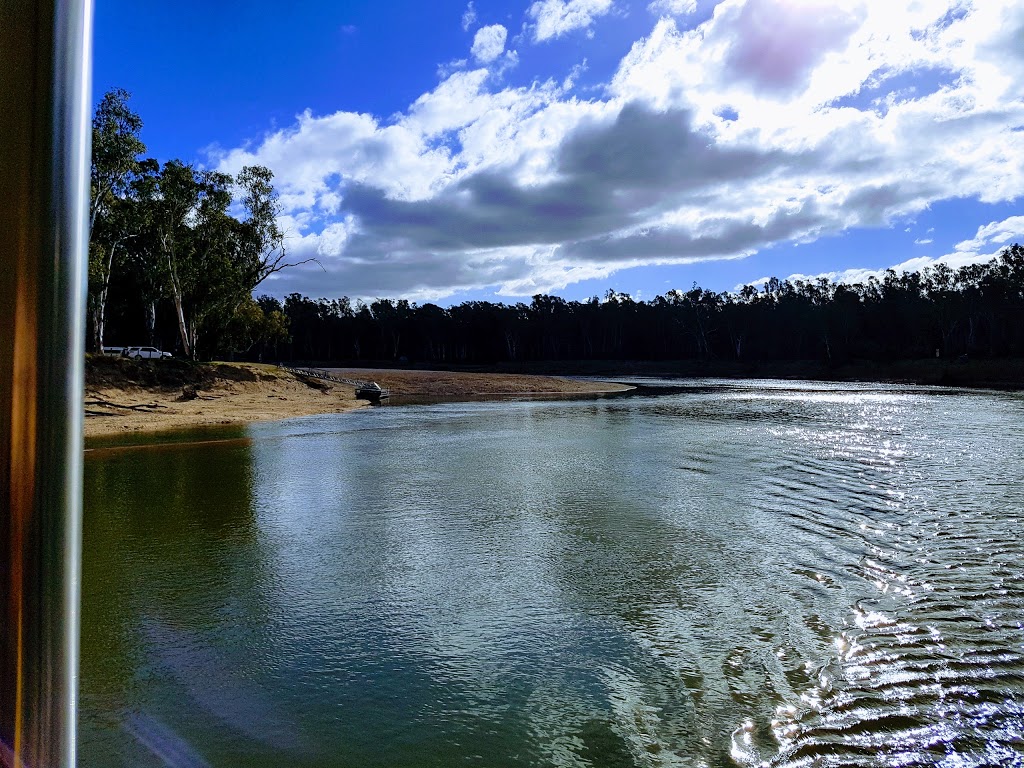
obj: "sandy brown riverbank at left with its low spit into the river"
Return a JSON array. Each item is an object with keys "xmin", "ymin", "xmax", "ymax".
[{"xmin": 85, "ymin": 358, "xmax": 628, "ymax": 437}]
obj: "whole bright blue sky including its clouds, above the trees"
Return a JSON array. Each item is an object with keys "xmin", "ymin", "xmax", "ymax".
[{"xmin": 93, "ymin": 0, "xmax": 1024, "ymax": 304}]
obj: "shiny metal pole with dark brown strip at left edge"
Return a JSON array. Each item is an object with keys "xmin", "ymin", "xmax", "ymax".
[{"xmin": 0, "ymin": 0, "xmax": 92, "ymax": 768}]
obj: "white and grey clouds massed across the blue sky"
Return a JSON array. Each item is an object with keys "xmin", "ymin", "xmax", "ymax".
[{"xmin": 211, "ymin": 0, "xmax": 1024, "ymax": 299}]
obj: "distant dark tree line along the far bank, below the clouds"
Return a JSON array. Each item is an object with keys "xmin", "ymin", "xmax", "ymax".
[{"xmin": 259, "ymin": 245, "xmax": 1024, "ymax": 365}]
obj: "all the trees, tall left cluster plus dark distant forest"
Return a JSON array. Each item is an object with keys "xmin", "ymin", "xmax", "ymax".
[{"xmin": 89, "ymin": 90, "xmax": 1024, "ymax": 365}]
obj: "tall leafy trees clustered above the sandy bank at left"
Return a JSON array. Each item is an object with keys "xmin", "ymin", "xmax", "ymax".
[{"xmin": 89, "ymin": 89, "xmax": 303, "ymax": 358}]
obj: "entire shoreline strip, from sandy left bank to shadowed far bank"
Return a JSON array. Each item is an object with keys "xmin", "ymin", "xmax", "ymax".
[{"xmin": 84, "ymin": 355, "xmax": 1024, "ymax": 439}]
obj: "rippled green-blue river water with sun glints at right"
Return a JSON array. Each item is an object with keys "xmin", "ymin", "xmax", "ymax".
[{"xmin": 81, "ymin": 382, "xmax": 1024, "ymax": 767}]
